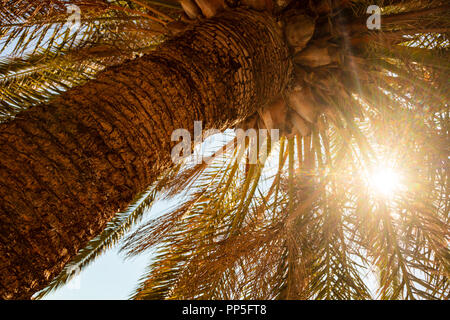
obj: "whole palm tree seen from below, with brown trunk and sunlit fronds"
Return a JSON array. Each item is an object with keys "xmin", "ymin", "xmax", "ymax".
[{"xmin": 0, "ymin": 0, "xmax": 450, "ymax": 299}]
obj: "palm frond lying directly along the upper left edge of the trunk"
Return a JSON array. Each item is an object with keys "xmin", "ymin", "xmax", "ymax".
[{"xmin": 0, "ymin": 39, "xmax": 158, "ymax": 121}]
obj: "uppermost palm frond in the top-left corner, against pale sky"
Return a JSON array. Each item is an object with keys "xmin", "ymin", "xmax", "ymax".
[{"xmin": 0, "ymin": 0, "xmax": 166, "ymax": 56}]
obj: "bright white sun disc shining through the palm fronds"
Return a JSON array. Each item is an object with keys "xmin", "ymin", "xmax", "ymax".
[{"xmin": 369, "ymin": 166, "xmax": 401, "ymax": 196}]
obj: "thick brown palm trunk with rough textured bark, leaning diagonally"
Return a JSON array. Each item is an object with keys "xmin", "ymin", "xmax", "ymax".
[{"xmin": 0, "ymin": 11, "xmax": 291, "ymax": 299}]
